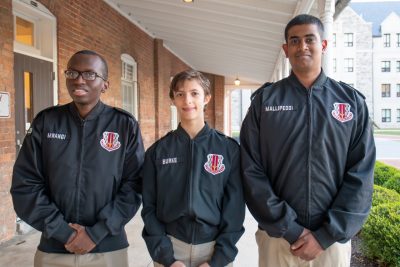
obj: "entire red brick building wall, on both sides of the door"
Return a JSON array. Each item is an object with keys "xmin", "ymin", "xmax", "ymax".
[{"xmin": 0, "ymin": 0, "xmax": 223, "ymax": 243}]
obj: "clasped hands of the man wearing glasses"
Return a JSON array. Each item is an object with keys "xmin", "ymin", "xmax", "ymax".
[{"xmin": 65, "ymin": 223, "xmax": 96, "ymax": 255}]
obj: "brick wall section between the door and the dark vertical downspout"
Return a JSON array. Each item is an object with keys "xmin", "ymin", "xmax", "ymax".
[{"xmin": 39, "ymin": 0, "xmax": 155, "ymax": 146}]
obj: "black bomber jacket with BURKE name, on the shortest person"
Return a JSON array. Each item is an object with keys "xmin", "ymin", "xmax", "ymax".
[{"xmin": 142, "ymin": 124, "xmax": 245, "ymax": 267}]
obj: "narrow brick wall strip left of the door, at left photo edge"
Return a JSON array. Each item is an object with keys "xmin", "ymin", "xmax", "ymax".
[{"xmin": 0, "ymin": 0, "xmax": 15, "ymax": 243}]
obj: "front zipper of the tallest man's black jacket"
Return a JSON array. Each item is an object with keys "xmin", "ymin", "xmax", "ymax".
[{"xmin": 306, "ymin": 87, "xmax": 312, "ymax": 229}]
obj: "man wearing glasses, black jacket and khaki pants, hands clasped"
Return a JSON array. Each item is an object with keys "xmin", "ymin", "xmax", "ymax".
[{"xmin": 11, "ymin": 50, "xmax": 144, "ymax": 267}]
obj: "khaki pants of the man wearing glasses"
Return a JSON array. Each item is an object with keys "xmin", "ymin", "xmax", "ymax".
[{"xmin": 34, "ymin": 248, "xmax": 129, "ymax": 267}]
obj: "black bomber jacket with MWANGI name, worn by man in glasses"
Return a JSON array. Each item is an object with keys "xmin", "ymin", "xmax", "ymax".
[{"xmin": 11, "ymin": 102, "xmax": 144, "ymax": 253}]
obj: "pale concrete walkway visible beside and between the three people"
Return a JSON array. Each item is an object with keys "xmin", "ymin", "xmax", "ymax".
[{"xmin": 0, "ymin": 211, "xmax": 258, "ymax": 267}]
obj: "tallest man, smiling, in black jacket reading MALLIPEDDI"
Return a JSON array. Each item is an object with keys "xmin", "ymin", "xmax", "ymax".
[{"xmin": 240, "ymin": 15, "xmax": 375, "ymax": 267}]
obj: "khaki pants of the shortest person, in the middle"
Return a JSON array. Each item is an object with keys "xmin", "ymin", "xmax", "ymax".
[{"xmin": 154, "ymin": 236, "xmax": 233, "ymax": 267}]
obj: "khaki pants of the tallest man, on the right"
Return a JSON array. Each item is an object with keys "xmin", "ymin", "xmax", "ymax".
[{"xmin": 256, "ymin": 229, "xmax": 351, "ymax": 267}]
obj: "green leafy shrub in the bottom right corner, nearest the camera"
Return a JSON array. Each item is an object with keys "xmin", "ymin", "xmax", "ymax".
[{"xmin": 361, "ymin": 202, "xmax": 400, "ymax": 267}]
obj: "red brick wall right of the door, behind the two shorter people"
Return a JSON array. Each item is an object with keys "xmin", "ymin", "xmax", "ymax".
[{"xmin": 40, "ymin": 0, "xmax": 223, "ymax": 147}]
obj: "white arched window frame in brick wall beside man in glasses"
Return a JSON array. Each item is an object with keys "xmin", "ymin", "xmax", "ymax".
[{"xmin": 121, "ymin": 54, "xmax": 139, "ymax": 119}]
